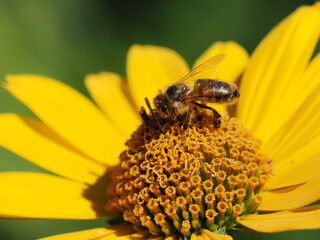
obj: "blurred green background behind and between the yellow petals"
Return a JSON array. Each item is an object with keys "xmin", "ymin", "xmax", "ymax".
[{"xmin": 0, "ymin": 0, "xmax": 320, "ymax": 240}]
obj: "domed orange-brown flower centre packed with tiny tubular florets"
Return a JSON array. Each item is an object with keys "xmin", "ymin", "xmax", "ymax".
[{"xmin": 107, "ymin": 112, "xmax": 272, "ymax": 239}]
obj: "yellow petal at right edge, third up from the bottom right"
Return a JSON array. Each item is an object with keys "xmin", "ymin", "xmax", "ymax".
[{"xmin": 268, "ymin": 153, "xmax": 320, "ymax": 189}]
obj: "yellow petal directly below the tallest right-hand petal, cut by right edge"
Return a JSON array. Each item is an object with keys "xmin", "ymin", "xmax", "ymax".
[{"xmin": 263, "ymin": 54, "xmax": 320, "ymax": 158}]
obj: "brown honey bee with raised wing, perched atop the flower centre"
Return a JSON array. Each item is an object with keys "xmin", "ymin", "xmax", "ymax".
[{"xmin": 140, "ymin": 54, "xmax": 240, "ymax": 128}]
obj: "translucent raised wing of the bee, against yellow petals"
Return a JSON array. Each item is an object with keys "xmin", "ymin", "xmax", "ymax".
[{"xmin": 179, "ymin": 54, "xmax": 225, "ymax": 85}]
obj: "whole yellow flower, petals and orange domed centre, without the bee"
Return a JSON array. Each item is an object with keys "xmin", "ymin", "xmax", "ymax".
[{"xmin": 0, "ymin": 1, "xmax": 320, "ymax": 239}]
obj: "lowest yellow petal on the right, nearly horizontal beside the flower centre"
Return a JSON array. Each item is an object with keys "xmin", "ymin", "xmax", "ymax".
[{"xmin": 238, "ymin": 208, "xmax": 320, "ymax": 233}]
